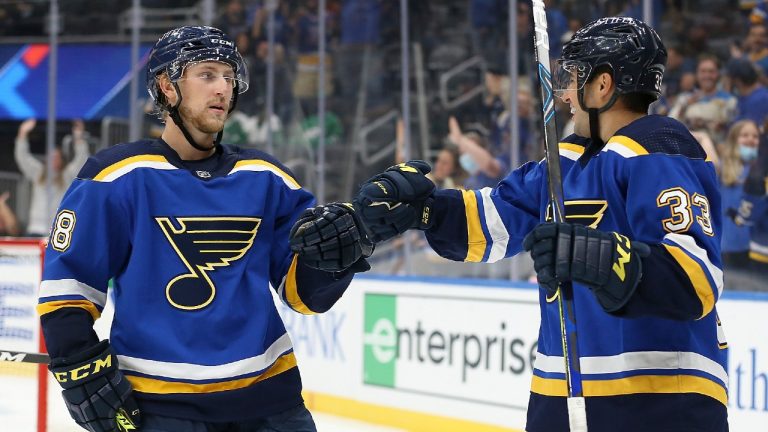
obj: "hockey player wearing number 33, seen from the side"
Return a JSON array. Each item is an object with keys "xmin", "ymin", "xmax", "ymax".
[{"xmin": 355, "ymin": 17, "xmax": 728, "ymax": 432}]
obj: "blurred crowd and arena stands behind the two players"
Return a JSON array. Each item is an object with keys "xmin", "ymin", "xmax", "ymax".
[{"xmin": 0, "ymin": 0, "xmax": 768, "ymax": 291}]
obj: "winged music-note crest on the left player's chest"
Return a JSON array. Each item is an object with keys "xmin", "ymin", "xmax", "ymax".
[{"xmin": 155, "ymin": 217, "xmax": 261, "ymax": 310}]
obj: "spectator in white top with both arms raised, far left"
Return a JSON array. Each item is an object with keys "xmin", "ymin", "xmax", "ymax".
[{"xmin": 14, "ymin": 119, "xmax": 88, "ymax": 237}]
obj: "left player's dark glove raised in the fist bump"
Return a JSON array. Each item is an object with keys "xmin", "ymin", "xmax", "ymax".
[{"xmin": 290, "ymin": 203, "xmax": 373, "ymax": 273}]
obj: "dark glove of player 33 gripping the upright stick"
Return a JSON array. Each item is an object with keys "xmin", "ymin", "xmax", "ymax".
[{"xmin": 523, "ymin": 223, "xmax": 651, "ymax": 312}]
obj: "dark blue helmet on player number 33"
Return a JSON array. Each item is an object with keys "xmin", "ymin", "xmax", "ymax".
[{"xmin": 555, "ymin": 17, "xmax": 667, "ymax": 99}]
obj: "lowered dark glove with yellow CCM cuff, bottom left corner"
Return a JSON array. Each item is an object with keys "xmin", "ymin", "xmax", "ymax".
[{"xmin": 48, "ymin": 341, "xmax": 141, "ymax": 432}]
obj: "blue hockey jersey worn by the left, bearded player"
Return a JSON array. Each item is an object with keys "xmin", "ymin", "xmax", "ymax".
[{"xmin": 38, "ymin": 140, "xmax": 352, "ymax": 422}]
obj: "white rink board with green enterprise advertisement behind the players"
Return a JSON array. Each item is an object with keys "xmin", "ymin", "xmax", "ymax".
[{"xmin": 280, "ymin": 277, "xmax": 768, "ymax": 431}]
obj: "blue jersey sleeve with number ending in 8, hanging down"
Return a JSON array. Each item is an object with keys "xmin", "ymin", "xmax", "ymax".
[{"xmin": 37, "ymin": 169, "xmax": 132, "ymax": 358}]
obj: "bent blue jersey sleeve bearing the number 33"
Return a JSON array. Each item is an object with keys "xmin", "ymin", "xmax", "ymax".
[{"xmin": 616, "ymin": 153, "xmax": 723, "ymax": 319}]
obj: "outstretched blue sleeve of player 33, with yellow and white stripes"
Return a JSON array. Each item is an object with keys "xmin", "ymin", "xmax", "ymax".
[{"xmin": 426, "ymin": 162, "xmax": 547, "ymax": 262}]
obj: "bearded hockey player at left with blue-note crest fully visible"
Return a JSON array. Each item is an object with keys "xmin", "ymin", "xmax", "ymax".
[{"xmin": 38, "ymin": 26, "xmax": 371, "ymax": 432}]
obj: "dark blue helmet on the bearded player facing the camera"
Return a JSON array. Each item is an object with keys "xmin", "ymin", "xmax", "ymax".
[{"xmin": 147, "ymin": 26, "xmax": 248, "ymax": 103}]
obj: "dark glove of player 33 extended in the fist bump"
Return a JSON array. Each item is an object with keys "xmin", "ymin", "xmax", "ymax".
[{"xmin": 353, "ymin": 160, "xmax": 435, "ymax": 243}]
